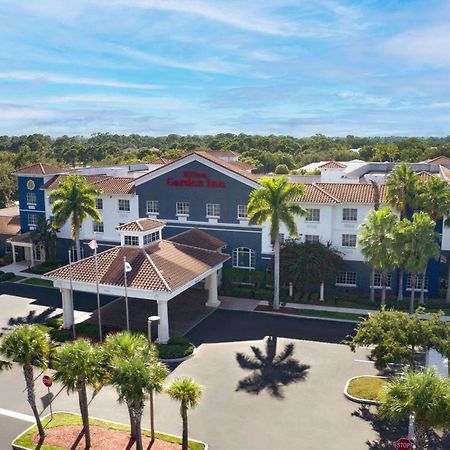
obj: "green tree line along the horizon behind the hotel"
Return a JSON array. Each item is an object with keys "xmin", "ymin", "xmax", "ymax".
[{"xmin": 0, "ymin": 133, "xmax": 450, "ymax": 207}]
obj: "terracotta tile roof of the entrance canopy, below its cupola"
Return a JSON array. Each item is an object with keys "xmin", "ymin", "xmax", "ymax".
[{"xmin": 45, "ymin": 241, "xmax": 230, "ymax": 292}]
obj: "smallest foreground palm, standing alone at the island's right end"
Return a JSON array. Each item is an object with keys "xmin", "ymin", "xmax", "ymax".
[{"xmin": 167, "ymin": 377, "xmax": 202, "ymax": 450}]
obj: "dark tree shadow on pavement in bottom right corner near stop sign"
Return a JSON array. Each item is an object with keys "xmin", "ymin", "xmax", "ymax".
[{"xmin": 352, "ymin": 406, "xmax": 450, "ymax": 450}]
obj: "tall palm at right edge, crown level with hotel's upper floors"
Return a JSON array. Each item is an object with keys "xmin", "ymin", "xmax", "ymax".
[{"xmin": 420, "ymin": 176, "xmax": 450, "ymax": 303}]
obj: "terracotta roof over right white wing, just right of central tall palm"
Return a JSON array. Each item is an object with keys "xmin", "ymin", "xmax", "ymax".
[{"xmin": 295, "ymin": 183, "xmax": 385, "ymax": 203}]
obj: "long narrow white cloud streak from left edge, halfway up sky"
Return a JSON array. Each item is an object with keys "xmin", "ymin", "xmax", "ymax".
[{"xmin": 0, "ymin": 71, "xmax": 161, "ymax": 89}]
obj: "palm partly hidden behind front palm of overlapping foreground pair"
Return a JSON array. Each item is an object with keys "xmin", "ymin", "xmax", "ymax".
[{"xmin": 103, "ymin": 331, "xmax": 156, "ymax": 439}]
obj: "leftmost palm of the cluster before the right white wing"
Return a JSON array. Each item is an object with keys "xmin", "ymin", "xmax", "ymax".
[{"xmin": 358, "ymin": 208, "xmax": 398, "ymax": 306}]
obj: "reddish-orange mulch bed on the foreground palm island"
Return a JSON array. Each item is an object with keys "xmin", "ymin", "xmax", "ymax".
[{"xmin": 33, "ymin": 425, "xmax": 185, "ymax": 450}]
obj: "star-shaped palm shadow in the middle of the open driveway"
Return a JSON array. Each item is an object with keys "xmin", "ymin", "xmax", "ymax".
[{"xmin": 236, "ymin": 336, "xmax": 310, "ymax": 399}]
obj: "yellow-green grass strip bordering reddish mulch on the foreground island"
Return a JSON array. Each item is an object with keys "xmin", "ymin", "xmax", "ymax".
[{"xmin": 13, "ymin": 413, "xmax": 205, "ymax": 450}]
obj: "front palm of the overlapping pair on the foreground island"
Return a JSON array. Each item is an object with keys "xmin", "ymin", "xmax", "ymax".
[{"xmin": 110, "ymin": 355, "xmax": 152, "ymax": 450}]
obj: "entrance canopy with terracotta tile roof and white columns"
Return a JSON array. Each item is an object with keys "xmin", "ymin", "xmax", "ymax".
[{"xmin": 45, "ymin": 223, "xmax": 229, "ymax": 343}]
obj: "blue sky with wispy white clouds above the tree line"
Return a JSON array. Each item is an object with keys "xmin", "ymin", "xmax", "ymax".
[{"xmin": 0, "ymin": 0, "xmax": 450, "ymax": 136}]
